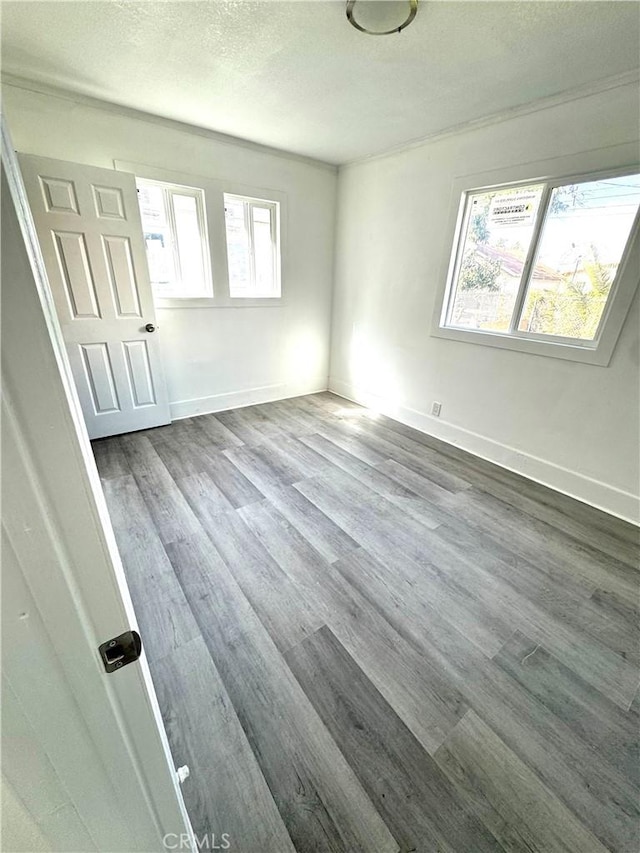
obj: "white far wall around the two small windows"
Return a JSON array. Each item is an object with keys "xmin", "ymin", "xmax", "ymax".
[{"xmin": 3, "ymin": 85, "xmax": 337, "ymax": 417}]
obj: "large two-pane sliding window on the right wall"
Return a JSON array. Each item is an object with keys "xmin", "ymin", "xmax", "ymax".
[{"xmin": 440, "ymin": 173, "xmax": 640, "ymax": 357}]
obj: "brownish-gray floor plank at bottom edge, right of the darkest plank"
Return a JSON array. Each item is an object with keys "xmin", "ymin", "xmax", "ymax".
[{"xmin": 435, "ymin": 711, "xmax": 607, "ymax": 853}]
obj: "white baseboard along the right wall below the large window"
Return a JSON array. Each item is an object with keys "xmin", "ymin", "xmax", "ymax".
[{"xmin": 329, "ymin": 377, "xmax": 640, "ymax": 525}]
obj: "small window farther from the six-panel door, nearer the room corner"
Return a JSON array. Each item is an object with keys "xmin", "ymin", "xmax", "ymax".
[{"xmin": 224, "ymin": 193, "xmax": 280, "ymax": 298}]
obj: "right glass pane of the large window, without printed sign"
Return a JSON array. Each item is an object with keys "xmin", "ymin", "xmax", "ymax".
[{"xmin": 518, "ymin": 175, "xmax": 640, "ymax": 340}]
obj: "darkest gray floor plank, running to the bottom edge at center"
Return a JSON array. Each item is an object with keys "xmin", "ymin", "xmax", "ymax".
[{"xmin": 285, "ymin": 628, "xmax": 501, "ymax": 853}]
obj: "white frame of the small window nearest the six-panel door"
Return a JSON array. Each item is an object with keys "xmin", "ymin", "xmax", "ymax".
[{"xmin": 136, "ymin": 175, "xmax": 214, "ymax": 304}]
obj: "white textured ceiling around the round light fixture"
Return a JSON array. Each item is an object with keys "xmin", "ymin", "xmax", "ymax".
[{"xmin": 2, "ymin": 0, "xmax": 640, "ymax": 163}]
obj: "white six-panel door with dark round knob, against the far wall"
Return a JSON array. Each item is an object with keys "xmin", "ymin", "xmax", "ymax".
[{"xmin": 19, "ymin": 154, "xmax": 170, "ymax": 438}]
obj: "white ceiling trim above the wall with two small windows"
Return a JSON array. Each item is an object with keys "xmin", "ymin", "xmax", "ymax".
[{"xmin": 2, "ymin": 72, "xmax": 338, "ymax": 172}]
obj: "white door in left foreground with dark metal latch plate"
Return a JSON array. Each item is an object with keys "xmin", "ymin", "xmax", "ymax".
[{"xmin": 0, "ymin": 126, "xmax": 195, "ymax": 853}]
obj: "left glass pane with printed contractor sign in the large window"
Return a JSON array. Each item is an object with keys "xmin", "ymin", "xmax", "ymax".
[{"xmin": 446, "ymin": 184, "xmax": 544, "ymax": 332}]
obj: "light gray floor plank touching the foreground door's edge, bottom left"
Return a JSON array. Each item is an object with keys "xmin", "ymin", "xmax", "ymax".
[{"xmin": 153, "ymin": 635, "xmax": 295, "ymax": 853}]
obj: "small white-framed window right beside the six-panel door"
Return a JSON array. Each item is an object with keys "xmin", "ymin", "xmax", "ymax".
[{"xmin": 136, "ymin": 180, "xmax": 213, "ymax": 299}]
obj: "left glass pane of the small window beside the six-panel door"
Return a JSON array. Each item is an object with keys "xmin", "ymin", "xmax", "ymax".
[{"xmin": 138, "ymin": 184, "xmax": 176, "ymax": 296}]
